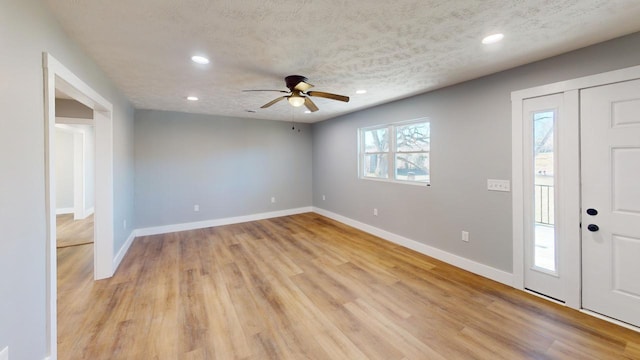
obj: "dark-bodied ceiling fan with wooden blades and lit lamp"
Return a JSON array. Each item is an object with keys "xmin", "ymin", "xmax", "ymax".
[{"xmin": 243, "ymin": 75, "xmax": 349, "ymax": 112}]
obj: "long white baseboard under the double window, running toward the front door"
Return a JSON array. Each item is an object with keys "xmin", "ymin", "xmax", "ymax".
[{"xmin": 313, "ymin": 207, "xmax": 513, "ymax": 286}]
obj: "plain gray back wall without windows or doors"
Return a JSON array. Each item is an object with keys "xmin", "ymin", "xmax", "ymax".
[{"xmin": 135, "ymin": 110, "xmax": 312, "ymax": 228}]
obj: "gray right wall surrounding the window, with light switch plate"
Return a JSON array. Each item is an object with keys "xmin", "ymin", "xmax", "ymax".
[{"xmin": 313, "ymin": 34, "xmax": 640, "ymax": 272}]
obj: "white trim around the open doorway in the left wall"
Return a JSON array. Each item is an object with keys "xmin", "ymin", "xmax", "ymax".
[{"xmin": 42, "ymin": 52, "xmax": 114, "ymax": 360}]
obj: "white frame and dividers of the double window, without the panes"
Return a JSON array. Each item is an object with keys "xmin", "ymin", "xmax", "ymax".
[{"xmin": 358, "ymin": 117, "xmax": 431, "ymax": 186}]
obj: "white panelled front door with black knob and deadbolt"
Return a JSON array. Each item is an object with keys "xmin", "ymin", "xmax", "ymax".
[{"xmin": 580, "ymin": 80, "xmax": 640, "ymax": 326}]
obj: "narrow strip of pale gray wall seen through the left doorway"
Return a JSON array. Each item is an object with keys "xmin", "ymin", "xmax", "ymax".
[{"xmin": 56, "ymin": 129, "xmax": 74, "ymax": 211}]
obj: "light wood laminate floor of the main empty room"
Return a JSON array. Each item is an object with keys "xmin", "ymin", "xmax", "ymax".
[{"xmin": 58, "ymin": 213, "xmax": 640, "ymax": 360}]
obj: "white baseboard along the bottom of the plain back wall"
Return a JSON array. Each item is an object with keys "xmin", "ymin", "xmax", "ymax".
[{"xmin": 136, "ymin": 206, "xmax": 313, "ymax": 236}]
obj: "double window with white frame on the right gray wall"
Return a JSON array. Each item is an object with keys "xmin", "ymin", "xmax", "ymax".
[{"xmin": 359, "ymin": 119, "xmax": 431, "ymax": 184}]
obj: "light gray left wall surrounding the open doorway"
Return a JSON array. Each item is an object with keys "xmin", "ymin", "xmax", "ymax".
[{"xmin": 0, "ymin": 0, "xmax": 133, "ymax": 360}]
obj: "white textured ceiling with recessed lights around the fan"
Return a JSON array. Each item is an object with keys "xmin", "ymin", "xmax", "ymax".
[{"xmin": 46, "ymin": 0, "xmax": 640, "ymax": 122}]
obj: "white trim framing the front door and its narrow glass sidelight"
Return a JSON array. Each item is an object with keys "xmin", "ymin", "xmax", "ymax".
[{"xmin": 511, "ymin": 66, "xmax": 640, "ymax": 309}]
